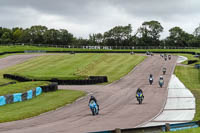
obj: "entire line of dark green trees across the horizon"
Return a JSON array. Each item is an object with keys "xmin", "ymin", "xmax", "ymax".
[{"xmin": 0, "ymin": 20, "xmax": 200, "ymax": 47}]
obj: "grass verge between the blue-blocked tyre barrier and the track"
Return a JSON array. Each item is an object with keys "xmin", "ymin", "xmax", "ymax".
[{"xmin": 0, "ymin": 90, "xmax": 85, "ymax": 123}]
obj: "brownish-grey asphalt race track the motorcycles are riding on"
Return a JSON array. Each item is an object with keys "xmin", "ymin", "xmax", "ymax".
[{"xmin": 0, "ymin": 55, "xmax": 177, "ymax": 133}]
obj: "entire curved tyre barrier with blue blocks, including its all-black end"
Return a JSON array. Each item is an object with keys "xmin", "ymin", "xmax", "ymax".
[{"xmin": 0, "ymin": 83, "xmax": 58, "ymax": 106}]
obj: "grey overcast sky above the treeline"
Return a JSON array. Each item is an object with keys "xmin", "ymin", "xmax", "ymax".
[{"xmin": 0, "ymin": 0, "xmax": 200, "ymax": 38}]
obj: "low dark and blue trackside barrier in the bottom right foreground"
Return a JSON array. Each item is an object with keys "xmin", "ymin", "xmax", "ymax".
[{"xmin": 89, "ymin": 121, "xmax": 200, "ymax": 133}]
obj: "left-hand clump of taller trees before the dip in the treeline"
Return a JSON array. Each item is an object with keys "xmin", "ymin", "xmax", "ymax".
[{"xmin": 0, "ymin": 25, "xmax": 74, "ymax": 45}]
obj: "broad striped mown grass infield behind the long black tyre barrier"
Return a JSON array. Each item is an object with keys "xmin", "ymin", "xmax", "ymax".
[{"xmin": 0, "ymin": 54, "xmax": 146, "ymax": 82}]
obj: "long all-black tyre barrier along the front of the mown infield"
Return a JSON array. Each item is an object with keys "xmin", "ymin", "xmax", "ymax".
[{"xmin": 3, "ymin": 74, "xmax": 108, "ymax": 85}]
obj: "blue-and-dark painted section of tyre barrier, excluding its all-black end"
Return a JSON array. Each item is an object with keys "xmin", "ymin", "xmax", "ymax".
[{"xmin": 0, "ymin": 87, "xmax": 42, "ymax": 106}]
